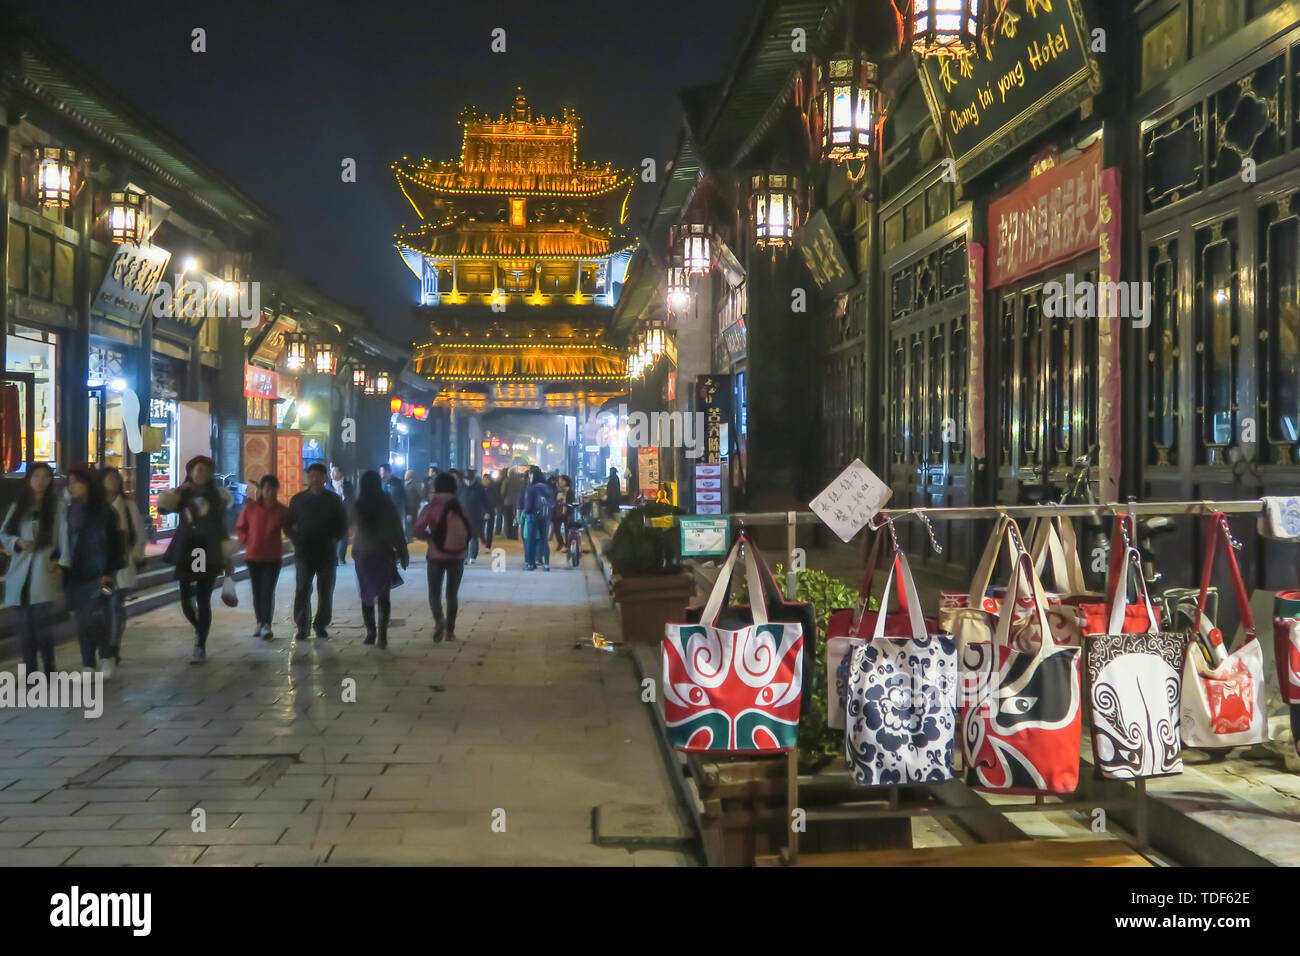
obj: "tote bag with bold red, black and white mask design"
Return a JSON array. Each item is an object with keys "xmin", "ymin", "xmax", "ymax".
[{"xmin": 959, "ymin": 541, "xmax": 1083, "ymax": 795}]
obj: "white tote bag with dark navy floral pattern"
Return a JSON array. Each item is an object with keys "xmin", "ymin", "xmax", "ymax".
[{"xmin": 844, "ymin": 551, "xmax": 957, "ymax": 787}]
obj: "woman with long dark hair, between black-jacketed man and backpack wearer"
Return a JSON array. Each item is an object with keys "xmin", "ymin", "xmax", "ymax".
[{"xmin": 352, "ymin": 471, "xmax": 405, "ymax": 649}]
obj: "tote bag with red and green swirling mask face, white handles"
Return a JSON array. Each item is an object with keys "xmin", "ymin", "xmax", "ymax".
[{"xmin": 663, "ymin": 536, "xmax": 803, "ymax": 753}]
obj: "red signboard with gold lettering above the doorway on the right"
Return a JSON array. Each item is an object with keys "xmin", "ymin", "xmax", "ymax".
[{"xmin": 988, "ymin": 142, "xmax": 1101, "ymax": 289}]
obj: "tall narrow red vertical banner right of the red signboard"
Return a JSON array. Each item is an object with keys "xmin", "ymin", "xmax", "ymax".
[{"xmin": 1097, "ymin": 169, "xmax": 1128, "ymax": 501}]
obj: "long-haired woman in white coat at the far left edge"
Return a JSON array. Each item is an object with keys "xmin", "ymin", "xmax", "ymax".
[{"xmin": 0, "ymin": 462, "xmax": 68, "ymax": 674}]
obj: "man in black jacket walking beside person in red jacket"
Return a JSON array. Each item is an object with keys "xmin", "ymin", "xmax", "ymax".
[{"xmin": 285, "ymin": 462, "xmax": 345, "ymax": 641}]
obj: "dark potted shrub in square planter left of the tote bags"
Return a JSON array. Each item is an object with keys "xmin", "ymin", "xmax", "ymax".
[{"xmin": 607, "ymin": 502, "xmax": 694, "ymax": 644}]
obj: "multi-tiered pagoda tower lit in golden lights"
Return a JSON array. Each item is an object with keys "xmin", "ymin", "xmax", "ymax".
[{"xmin": 393, "ymin": 90, "xmax": 636, "ymax": 463}]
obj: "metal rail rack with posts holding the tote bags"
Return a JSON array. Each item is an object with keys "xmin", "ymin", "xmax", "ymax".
[{"xmin": 646, "ymin": 498, "xmax": 1264, "ymax": 866}]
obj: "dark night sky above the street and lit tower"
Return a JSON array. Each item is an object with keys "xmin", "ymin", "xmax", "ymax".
[{"xmin": 13, "ymin": 0, "xmax": 757, "ymax": 335}]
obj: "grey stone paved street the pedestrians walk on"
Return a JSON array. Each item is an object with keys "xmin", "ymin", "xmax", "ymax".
[{"xmin": 0, "ymin": 541, "xmax": 692, "ymax": 866}]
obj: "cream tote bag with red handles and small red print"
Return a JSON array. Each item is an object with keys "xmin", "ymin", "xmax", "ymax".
[{"xmin": 1182, "ymin": 511, "xmax": 1269, "ymax": 749}]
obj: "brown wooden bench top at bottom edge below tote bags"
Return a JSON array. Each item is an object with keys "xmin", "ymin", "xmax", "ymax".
[{"xmin": 755, "ymin": 839, "xmax": 1151, "ymax": 866}]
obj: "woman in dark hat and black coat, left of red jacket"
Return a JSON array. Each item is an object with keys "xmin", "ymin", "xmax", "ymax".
[{"xmin": 159, "ymin": 455, "xmax": 234, "ymax": 663}]
